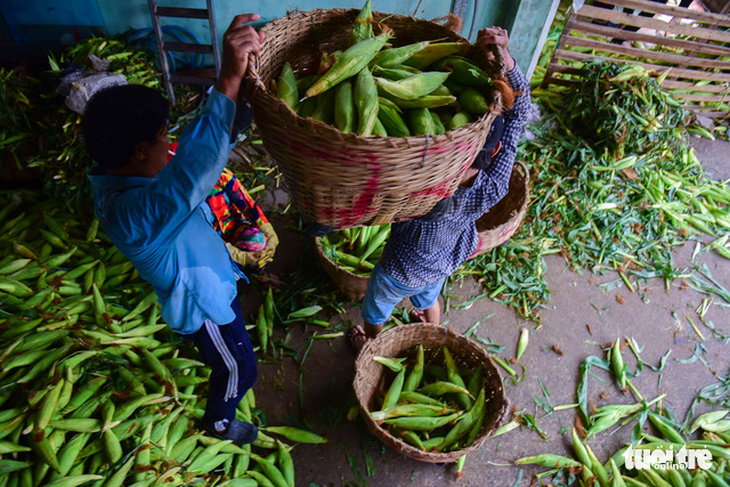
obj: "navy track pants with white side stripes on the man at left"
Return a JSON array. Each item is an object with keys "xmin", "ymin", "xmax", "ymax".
[{"xmin": 188, "ymin": 295, "xmax": 257, "ymax": 429}]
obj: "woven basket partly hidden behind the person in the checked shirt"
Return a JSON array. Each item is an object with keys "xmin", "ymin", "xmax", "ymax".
[{"xmin": 470, "ymin": 161, "xmax": 530, "ymax": 258}]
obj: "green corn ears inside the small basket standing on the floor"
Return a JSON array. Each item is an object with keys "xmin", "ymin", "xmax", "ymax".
[{"xmin": 368, "ymin": 345, "xmax": 486, "ymax": 452}]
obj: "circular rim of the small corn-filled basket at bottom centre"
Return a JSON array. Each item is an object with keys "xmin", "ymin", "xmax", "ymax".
[{"xmin": 353, "ymin": 323, "xmax": 509, "ymax": 463}]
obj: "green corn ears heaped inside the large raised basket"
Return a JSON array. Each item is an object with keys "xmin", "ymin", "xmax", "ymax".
[{"xmin": 276, "ymin": 0, "xmax": 504, "ymax": 137}]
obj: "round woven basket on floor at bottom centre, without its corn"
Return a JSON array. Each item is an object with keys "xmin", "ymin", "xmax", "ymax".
[{"xmin": 353, "ymin": 323, "xmax": 508, "ymax": 463}]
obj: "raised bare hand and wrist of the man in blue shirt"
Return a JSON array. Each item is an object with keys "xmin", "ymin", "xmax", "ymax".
[{"xmin": 216, "ymin": 14, "xmax": 264, "ymax": 100}]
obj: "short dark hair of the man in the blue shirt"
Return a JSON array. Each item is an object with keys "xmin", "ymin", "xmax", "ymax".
[{"xmin": 84, "ymin": 85, "xmax": 170, "ymax": 169}]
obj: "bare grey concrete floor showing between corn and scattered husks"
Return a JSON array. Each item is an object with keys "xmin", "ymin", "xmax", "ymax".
[{"xmin": 246, "ymin": 134, "xmax": 730, "ymax": 486}]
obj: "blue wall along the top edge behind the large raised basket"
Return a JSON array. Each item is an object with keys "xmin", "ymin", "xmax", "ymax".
[{"xmin": 0, "ymin": 0, "xmax": 559, "ymax": 76}]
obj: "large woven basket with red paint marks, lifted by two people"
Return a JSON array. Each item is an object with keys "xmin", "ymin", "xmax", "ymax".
[{"xmin": 247, "ymin": 9, "xmax": 502, "ymax": 228}]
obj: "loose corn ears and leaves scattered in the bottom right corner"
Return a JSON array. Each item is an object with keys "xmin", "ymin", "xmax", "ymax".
[{"xmin": 515, "ymin": 339, "xmax": 730, "ymax": 487}]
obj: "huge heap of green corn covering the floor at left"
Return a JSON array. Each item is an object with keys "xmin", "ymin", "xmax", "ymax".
[{"xmin": 0, "ymin": 192, "xmax": 325, "ymax": 487}]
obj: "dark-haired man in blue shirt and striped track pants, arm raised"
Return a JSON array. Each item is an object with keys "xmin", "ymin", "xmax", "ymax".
[{"xmin": 84, "ymin": 14, "xmax": 263, "ymax": 445}]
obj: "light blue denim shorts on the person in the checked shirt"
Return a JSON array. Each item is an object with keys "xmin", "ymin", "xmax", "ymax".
[{"xmin": 362, "ymin": 262, "xmax": 446, "ymax": 325}]
